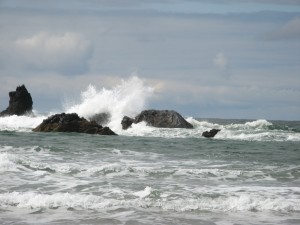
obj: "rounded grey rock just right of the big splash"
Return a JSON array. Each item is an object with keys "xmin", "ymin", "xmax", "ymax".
[{"xmin": 121, "ymin": 110, "xmax": 193, "ymax": 129}]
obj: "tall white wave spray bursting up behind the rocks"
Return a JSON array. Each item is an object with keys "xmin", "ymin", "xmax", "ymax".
[{"xmin": 65, "ymin": 76, "xmax": 153, "ymax": 130}]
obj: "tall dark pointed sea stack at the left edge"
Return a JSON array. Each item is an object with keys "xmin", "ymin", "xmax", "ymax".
[{"xmin": 0, "ymin": 85, "xmax": 33, "ymax": 116}]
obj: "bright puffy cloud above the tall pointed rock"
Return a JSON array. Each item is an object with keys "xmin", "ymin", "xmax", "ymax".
[{"xmin": 14, "ymin": 32, "xmax": 92, "ymax": 74}]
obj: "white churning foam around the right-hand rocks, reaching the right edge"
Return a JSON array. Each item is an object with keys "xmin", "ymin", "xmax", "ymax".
[{"xmin": 119, "ymin": 118, "xmax": 300, "ymax": 141}]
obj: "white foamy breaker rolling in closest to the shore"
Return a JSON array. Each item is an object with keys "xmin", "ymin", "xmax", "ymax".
[{"xmin": 0, "ymin": 187, "xmax": 300, "ymax": 213}]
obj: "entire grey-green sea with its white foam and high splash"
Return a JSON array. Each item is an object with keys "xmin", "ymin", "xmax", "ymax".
[{"xmin": 0, "ymin": 78, "xmax": 300, "ymax": 225}]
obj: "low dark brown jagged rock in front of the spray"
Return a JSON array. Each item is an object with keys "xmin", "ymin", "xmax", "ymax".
[{"xmin": 33, "ymin": 113, "xmax": 116, "ymax": 135}]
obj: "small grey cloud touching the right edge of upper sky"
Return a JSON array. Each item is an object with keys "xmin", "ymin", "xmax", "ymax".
[{"xmin": 267, "ymin": 17, "xmax": 300, "ymax": 41}]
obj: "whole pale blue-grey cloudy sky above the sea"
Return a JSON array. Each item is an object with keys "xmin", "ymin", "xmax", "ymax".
[{"xmin": 0, "ymin": 0, "xmax": 300, "ymax": 120}]
